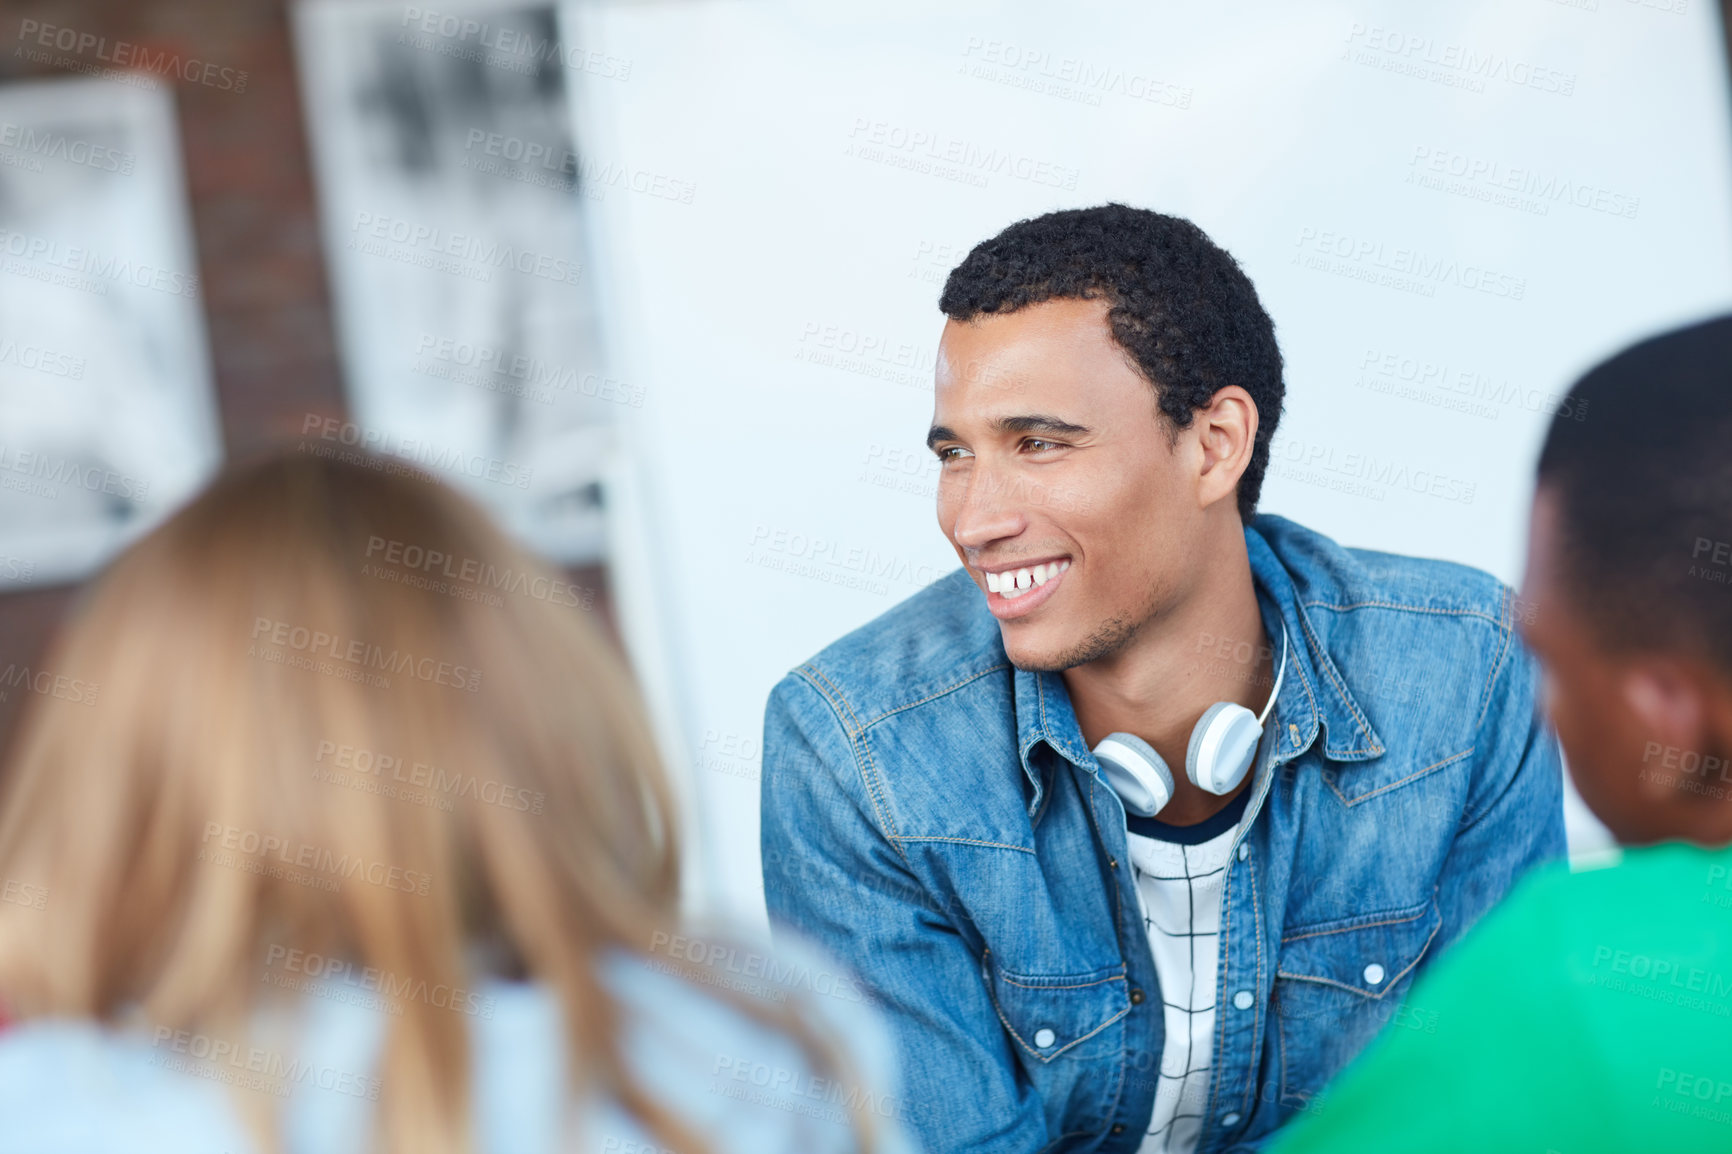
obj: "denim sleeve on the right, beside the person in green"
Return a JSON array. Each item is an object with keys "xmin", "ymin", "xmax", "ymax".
[{"xmin": 1438, "ymin": 594, "xmax": 1566, "ymax": 946}]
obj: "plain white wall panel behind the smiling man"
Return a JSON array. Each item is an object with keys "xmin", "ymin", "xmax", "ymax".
[{"xmin": 566, "ymin": 0, "xmax": 1732, "ymax": 917}]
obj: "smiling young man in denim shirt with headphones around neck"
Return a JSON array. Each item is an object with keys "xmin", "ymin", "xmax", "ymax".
[{"xmin": 762, "ymin": 204, "xmax": 1564, "ymax": 1154}]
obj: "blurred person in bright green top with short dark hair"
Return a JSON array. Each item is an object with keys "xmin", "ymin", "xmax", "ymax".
[{"xmin": 1275, "ymin": 317, "xmax": 1732, "ymax": 1154}]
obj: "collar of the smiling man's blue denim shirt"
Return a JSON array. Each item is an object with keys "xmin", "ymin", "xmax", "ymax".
[{"xmin": 1013, "ymin": 525, "xmax": 1384, "ymax": 820}]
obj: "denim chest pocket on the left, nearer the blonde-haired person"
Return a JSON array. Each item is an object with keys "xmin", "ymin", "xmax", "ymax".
[{"xmin": 980, "ymin": 950, "xmax": 1131, "ymax": 1062}]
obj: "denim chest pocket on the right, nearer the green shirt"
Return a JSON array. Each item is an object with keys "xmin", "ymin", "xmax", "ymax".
[{"xmin": 1275, "ymin": 896, "xmax": 1443, "ymax": 1107}]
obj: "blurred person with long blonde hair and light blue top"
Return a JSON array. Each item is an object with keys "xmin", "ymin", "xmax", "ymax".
[{"xmin": 0, "ymin": 454, "xmax": 906, "ymax": 1154}]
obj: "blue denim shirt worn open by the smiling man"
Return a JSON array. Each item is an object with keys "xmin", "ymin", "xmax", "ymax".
[{"xmin": 762, "ymin": 515, "xmax": 1564, "ymax": 1154}]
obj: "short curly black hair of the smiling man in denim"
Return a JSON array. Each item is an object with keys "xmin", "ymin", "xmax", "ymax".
[{"xmin": 939, "ymin": 204, "xmax": 1285, "ymax": 525}]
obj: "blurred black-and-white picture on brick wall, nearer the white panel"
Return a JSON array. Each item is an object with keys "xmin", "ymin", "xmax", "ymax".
[{"xmin": 296, "ymin": 0, "xmax": 620, "ymax": 563}]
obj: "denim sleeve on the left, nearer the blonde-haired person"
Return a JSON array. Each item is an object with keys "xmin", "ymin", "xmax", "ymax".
[{"xmin": 760, "ymin": 674, "xmax": 1050, "ymax": 1154}]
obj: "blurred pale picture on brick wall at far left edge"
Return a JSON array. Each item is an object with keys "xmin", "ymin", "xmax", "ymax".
[{"xmin": 0, "ymin": 76, "xmax": 222, "ymax": 589}]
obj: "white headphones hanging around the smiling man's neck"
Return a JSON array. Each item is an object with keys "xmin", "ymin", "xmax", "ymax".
[{"xmin": 1095, "ymin": 622, "xmax": 1287, "ymax": 818}]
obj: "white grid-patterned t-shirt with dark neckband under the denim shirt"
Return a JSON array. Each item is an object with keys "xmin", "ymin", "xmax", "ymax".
[{"xmin": 1126, "ymin": 749, "xmax": 1261, "ymax": 1154}]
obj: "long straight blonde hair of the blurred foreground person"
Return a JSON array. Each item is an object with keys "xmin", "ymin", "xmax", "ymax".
[{"xmin": 0, "ymin": 452, "xmax": 871, "ymax": 1154}]
